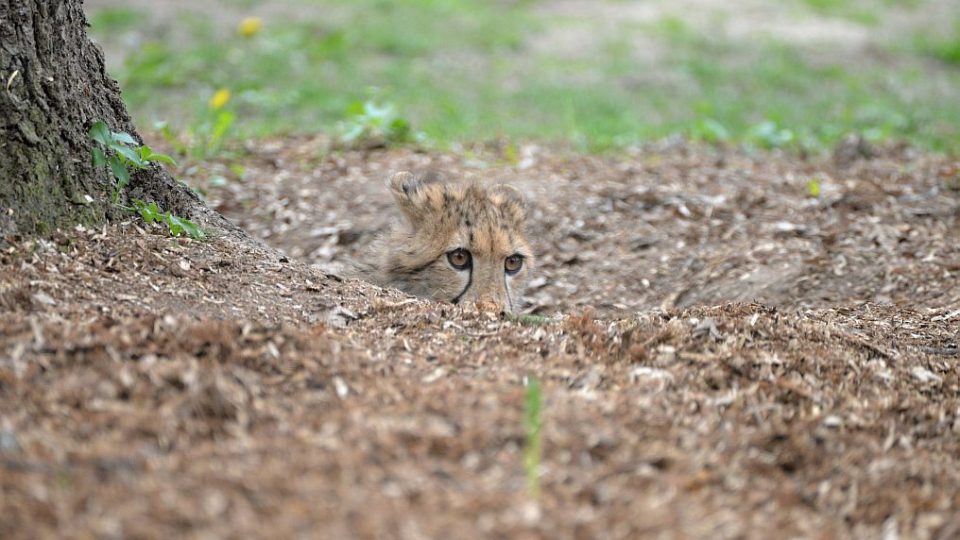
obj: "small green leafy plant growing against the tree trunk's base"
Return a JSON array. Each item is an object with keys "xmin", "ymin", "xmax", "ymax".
[{"xmin": 90, "ymin": 120, "xmax": 206, "ymax": 240}]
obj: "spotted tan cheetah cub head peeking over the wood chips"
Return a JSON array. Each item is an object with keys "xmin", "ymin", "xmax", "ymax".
[{"xmin": 365, "ymin": 172, "xmax": 533, "ymax": 312}]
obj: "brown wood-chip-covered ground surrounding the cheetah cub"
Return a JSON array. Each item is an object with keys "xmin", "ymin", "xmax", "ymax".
[{"xmin": 0, "ymin": 140, "xmax": 960, "ymax": 538}]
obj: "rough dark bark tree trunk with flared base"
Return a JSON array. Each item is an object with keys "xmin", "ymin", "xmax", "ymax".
[{"xmin": 0, "ymin": 0, "xmax": 223, "ymax": 236}]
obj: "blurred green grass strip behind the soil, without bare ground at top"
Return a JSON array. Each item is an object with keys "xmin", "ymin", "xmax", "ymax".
[{"xmin": 91, "ymin": 0, "xmax": 960, "ymax": 151}]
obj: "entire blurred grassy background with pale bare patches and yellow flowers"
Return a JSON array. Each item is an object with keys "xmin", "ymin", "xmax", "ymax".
[{"xmin": 85, "ymin": 0, "xmax": 960, "ymax": 152}]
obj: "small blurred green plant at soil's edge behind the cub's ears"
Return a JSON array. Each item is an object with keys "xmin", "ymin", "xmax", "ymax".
[{"xmin": 339, "ymin": 97, "xmax": 415, "ymax": 146}]
